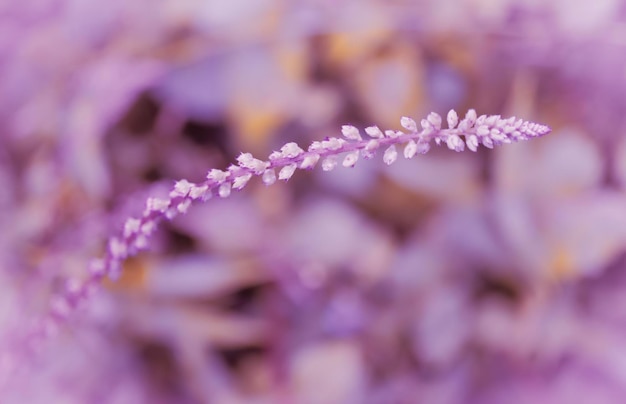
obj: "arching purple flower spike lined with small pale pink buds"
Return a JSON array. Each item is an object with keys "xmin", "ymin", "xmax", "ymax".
[{"xmin": 18, "ymin": 109, "xmax": 550, "ymax": 360}]
